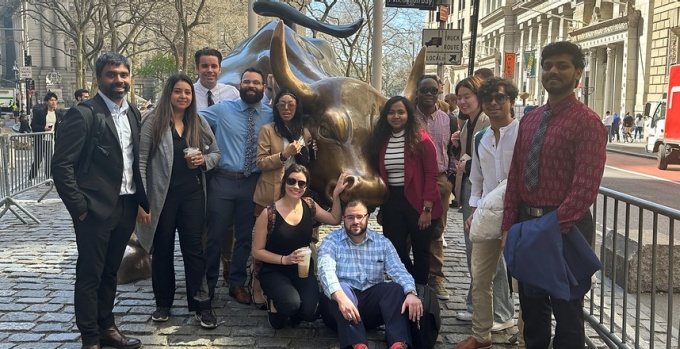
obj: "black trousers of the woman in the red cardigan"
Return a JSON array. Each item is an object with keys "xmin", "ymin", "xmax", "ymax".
[{"xmin": 381, "ymin": 187, "xmax": 439, "ymax": 285}]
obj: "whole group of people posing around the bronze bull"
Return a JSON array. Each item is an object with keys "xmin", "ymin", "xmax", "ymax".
[{"xmin": 50, "ymin": 38, "xmax": 604, "ymax": 349}]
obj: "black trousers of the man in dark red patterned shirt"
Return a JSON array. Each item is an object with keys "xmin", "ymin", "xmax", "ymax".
[{"xmin": 519, "ymin": 210, "xmax": 593, "ymax": 349}]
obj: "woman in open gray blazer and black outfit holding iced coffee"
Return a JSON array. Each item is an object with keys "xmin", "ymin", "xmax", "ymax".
[{"xmin": 137, "ymin": 74, "xmax": 220, "ymax": 328}]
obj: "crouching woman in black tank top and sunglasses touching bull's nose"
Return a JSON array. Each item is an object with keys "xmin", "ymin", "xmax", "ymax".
[{"xmin": 253, "ymin": 164, "xmax": 347, "ymax": 329}]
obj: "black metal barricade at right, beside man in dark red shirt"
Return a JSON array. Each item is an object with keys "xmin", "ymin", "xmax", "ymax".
[{"xmin": 584, "ymin": 188, "xmax": 680, "ymax": 349}]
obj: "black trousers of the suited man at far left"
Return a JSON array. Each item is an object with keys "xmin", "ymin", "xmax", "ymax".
[{"xmin": 73, "ymin": 195, "xmax": 137, "ymax": 345}]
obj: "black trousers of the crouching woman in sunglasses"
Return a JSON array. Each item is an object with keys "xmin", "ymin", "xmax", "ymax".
[{"xmin": 260, "ymin": 261, "xmax": 319, "ymax": 322}]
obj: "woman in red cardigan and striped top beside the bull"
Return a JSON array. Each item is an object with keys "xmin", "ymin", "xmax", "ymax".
[{"xmin": 367, "ymin": 96, "xmax": 442, "ymax": 285}]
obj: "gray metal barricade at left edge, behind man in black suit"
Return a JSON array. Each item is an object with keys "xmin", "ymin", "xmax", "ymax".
[{"xmin": 0, "ymin": 132, "xmax": 54, "ymax": 224}]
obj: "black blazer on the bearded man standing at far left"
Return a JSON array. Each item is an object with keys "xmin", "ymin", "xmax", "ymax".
[{"xmin": 52, "ymin": 95, "xmax": 149, "ymax": 220}]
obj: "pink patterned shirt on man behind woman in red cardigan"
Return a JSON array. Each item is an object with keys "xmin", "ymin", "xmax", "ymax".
[{"xmin": 416, "ymin": 106, "xmax": 455, "ymax": 173}]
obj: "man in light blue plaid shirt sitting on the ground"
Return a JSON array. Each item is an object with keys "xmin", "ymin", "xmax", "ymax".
[{"xmin": 318, "ymin": 201, "xmax": 423, "ymax": 349}]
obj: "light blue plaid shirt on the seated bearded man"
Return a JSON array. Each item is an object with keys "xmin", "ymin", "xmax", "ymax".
[{"xmin": 319, "ymin": 228, "xmax": 416, "ymax": 298}]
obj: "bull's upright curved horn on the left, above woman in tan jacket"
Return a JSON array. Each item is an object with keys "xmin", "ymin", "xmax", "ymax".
[{"xmin": 269, "ymin": 21, "xmax": 314, "ymax": 106}]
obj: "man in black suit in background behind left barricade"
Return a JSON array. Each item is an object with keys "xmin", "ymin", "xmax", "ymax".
[{"xmin": 28, "ymin": 91, "xmax": 64, "ymax": 179}]
